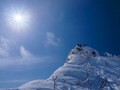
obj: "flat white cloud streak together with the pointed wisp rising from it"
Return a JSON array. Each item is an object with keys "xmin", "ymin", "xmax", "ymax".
[{"xmin": 0, "ymin": 43, "xmax": 51, "ymax": 69}]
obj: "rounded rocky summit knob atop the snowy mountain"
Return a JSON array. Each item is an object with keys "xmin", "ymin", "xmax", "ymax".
[{"xmin": 67, "ymin": 45, "xmax": 99, "ymax": 64}]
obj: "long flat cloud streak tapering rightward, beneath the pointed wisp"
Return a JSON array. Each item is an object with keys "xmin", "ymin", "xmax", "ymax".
[{"xmin": 0, "ymin": 56, "xmax": 51, "ymax": 69}]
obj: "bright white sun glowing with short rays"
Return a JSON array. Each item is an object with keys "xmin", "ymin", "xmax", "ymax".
[{"xmin": 7, "ymin": 9, "xmax": 30, "ymax": 31}]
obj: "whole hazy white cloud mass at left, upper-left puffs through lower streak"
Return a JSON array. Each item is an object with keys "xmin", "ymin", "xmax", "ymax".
[{"xmin": 0, "ymin": 37, "xmax": 50, "ymax": 69}]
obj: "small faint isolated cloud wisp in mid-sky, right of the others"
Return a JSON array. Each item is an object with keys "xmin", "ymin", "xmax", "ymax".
[{"xmin": 46, "ymin": 32, "xmax": 60, "ymax": 46}]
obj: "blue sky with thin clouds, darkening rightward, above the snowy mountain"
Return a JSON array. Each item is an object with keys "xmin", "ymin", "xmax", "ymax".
[{"xmin": 0, "ymin": 0, "xmax": 120, "ymax": 88}]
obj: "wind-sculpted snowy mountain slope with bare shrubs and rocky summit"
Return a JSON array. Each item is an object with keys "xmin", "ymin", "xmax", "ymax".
[{"xmin": 18, "ymin": 46, "xmax": 120, "ymax": 90}]
